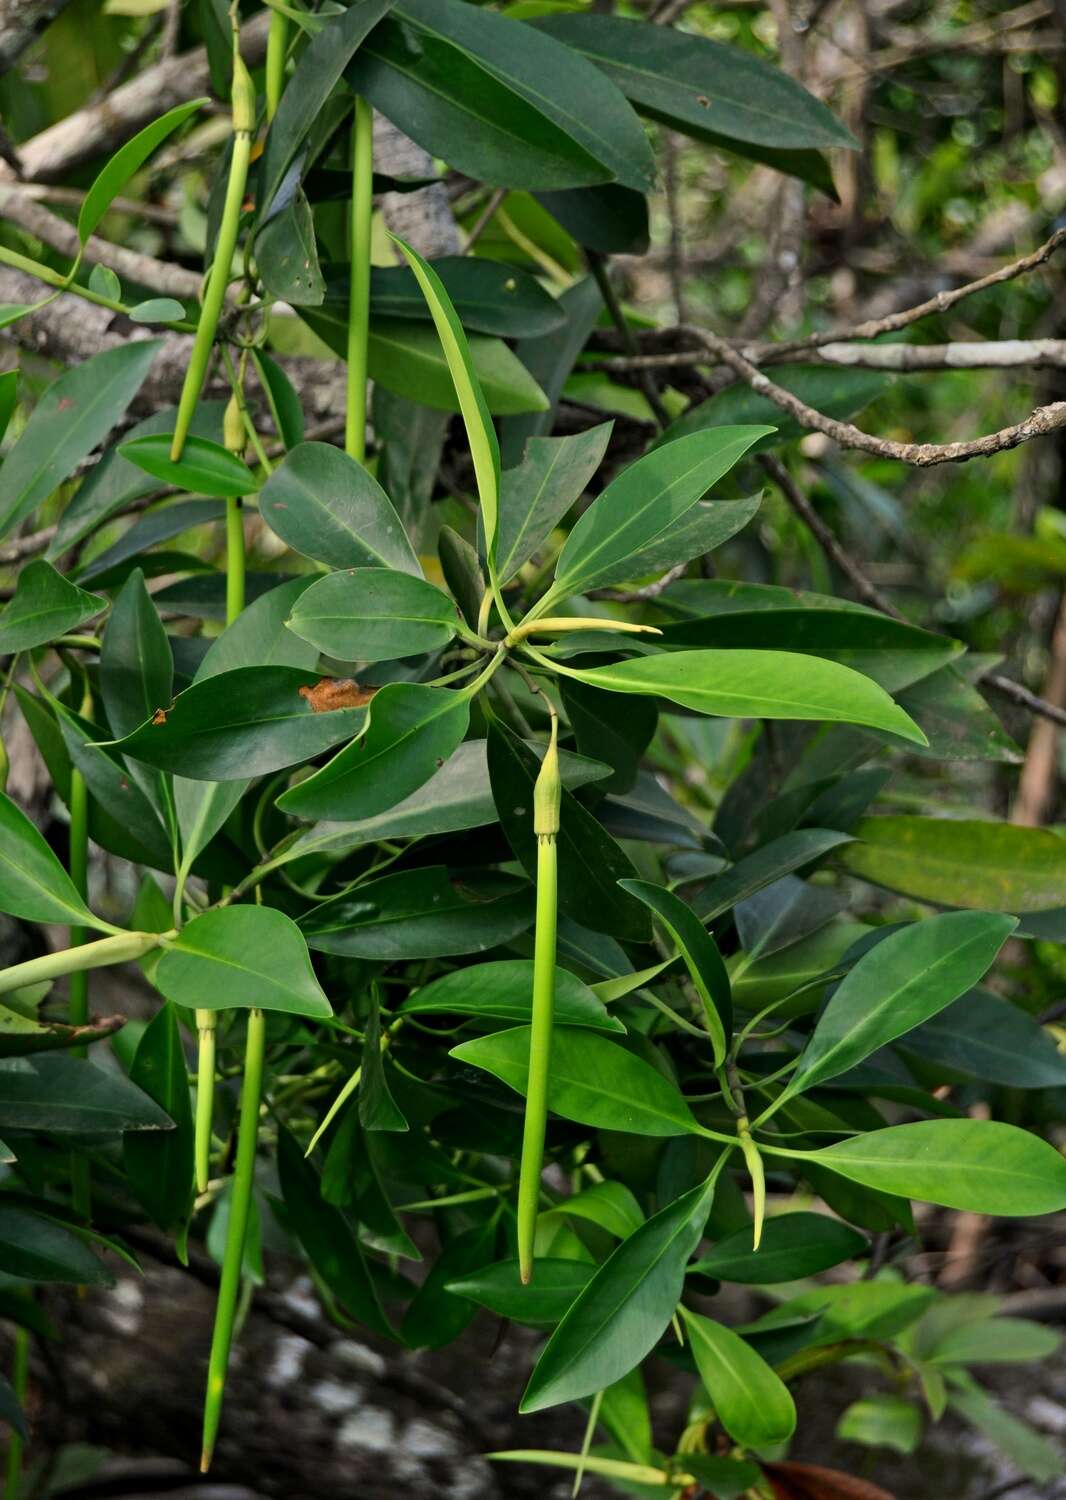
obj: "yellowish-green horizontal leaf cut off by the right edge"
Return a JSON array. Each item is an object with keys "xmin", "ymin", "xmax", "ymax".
[{"xmin": 838, "ymin": 816, "xmax": 1066, "ymax": 912}]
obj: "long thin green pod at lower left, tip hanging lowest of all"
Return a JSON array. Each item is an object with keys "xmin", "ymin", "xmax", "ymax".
[{"xmin": 199, "ymin": 1011, "xmax": 267, "ymax": 1475}]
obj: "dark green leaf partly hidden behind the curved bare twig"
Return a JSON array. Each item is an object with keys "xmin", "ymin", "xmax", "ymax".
[{"xmin": 660, "ymin": 365, "xmax": 895, "ymax": 453}]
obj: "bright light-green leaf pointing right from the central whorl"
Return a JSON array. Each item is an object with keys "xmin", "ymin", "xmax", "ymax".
[{"xmin": 567, "ymin": 651, "xmax": 929, "ymax": 744}]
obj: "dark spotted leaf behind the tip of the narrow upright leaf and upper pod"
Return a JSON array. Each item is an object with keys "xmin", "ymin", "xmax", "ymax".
[{"xmin": 367, "ymin": 255, "xmax": 565, "ymax": 339}]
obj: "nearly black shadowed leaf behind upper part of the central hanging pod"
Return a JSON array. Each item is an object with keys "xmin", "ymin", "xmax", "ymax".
[{"xmin": 489, "ymin": 723, "xmax": 651, "ymax": 941}]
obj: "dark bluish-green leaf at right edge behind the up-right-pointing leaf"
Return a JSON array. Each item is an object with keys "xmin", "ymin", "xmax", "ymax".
[{"xmin": 904, "ymin": 989, "xmax": 1066, "ymax": 1089}]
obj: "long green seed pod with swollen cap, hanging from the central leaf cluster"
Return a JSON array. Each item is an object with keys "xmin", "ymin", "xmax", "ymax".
[{"xmin": 519, "ymin": 713, "xmax": 562, "ymax": 1283}]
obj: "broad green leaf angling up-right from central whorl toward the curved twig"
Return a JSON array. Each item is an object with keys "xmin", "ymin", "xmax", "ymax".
[{"xmin": 543, "ymin": 428, "xmax": 769, "ymax": 609}]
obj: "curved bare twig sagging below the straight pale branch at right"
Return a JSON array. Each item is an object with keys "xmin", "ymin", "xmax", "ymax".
[{"xmin": 697, "ymin": 330, "xmax": 1066, "ymax": 468}]
